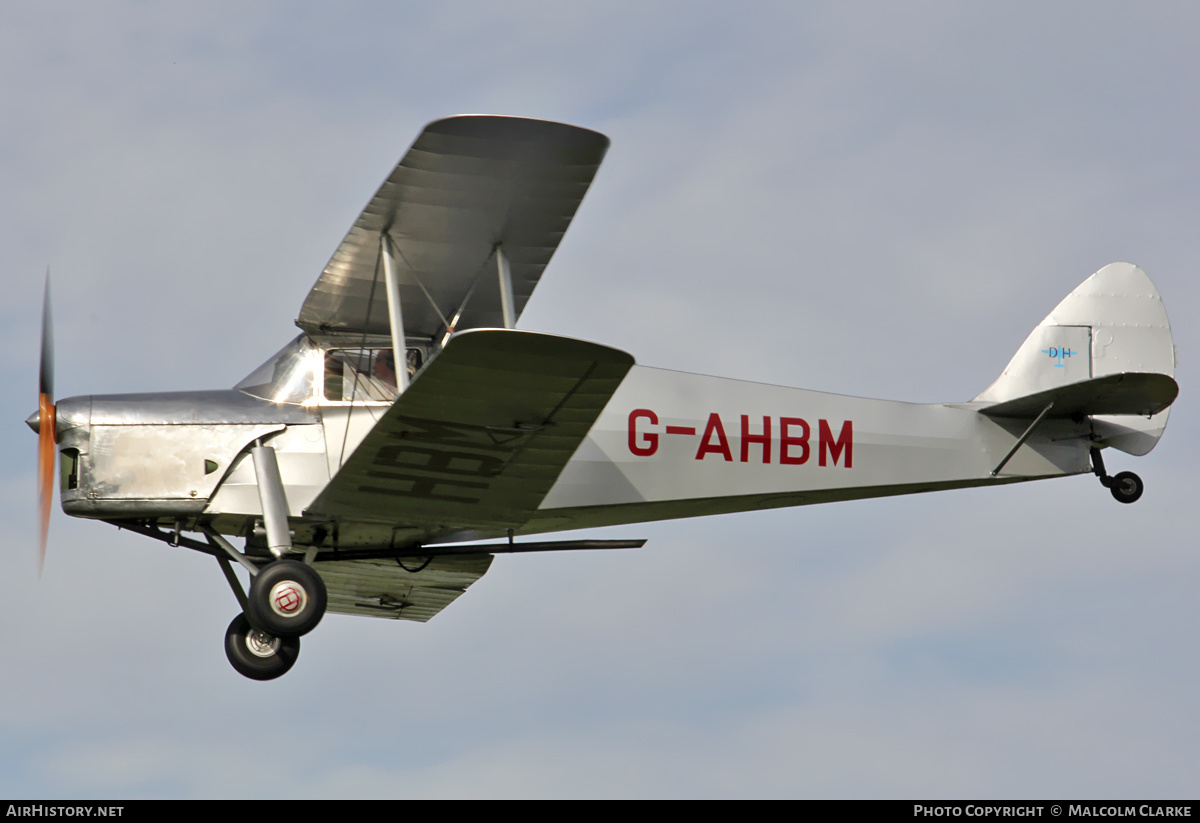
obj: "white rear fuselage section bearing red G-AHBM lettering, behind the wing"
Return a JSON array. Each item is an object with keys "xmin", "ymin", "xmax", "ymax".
[{"xmin": 534, "ymin": 366, "xmax": 1091, "ymax": 528}]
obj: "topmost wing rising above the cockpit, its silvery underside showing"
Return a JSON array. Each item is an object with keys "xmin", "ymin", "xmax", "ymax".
[{"xmin": 296, "ymin": 115, "xmax": 608, "ymax": 337}]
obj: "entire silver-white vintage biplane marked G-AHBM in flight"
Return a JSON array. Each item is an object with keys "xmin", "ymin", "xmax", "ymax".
[{"xmin": 26, "ymin": 115, "xmax": 1178, "ymax": 680}]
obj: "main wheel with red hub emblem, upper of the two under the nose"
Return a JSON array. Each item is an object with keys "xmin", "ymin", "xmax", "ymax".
[{"xmin": 246, "ymin": 560, "xmax": 329, "ymax": 637}]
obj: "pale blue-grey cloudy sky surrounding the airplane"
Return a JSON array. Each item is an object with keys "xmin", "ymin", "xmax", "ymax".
[{"xmin": 0, "ymin": 0, "xmax": 1200, "ymax": 799}]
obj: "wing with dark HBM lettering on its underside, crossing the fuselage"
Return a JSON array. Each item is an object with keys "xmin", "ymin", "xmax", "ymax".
[{"xmin": 306, "ymin": 329, "xmax": 634, "ymax": 537}]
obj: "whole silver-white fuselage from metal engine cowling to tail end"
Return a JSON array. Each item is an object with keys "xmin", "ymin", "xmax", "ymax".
[{"xmin": 49, "ymin": 350, "xmax": 1091, "ymax": 546}]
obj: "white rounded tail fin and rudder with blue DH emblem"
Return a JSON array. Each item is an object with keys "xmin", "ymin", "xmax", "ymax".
[{"xmin": 976, "ymin": 263, "xmax": 1175, "ymax": 455}]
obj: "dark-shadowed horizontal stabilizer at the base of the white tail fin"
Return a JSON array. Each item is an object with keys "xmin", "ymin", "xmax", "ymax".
[{"xmin": 979, "ymin": 372, "xmax": 1180, "ymax": 419}]
